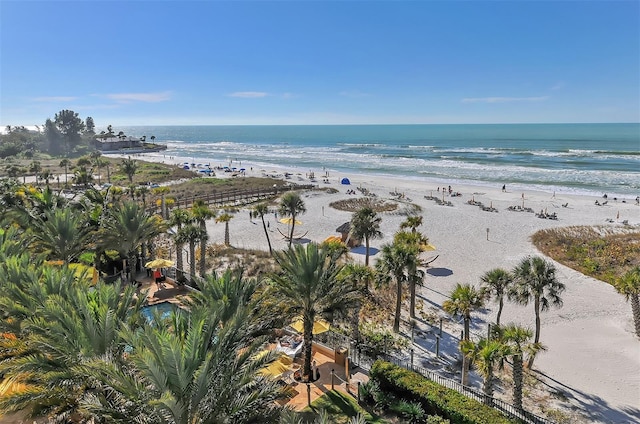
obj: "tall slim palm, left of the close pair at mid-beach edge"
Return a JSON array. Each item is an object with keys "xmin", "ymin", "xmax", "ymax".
[{"xmin": 372, "ymin": 243, "xmax": 411, "ymax": 333}]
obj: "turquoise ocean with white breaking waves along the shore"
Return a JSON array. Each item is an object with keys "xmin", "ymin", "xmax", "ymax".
[{"xmin": 118, "ymin": 124, "xmax": 640, "ymax": 198}]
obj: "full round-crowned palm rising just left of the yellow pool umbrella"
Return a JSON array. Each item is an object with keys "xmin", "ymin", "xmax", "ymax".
[{"xmin": 102, "ymin": 202, "xmax": 165, "ymax": 282}]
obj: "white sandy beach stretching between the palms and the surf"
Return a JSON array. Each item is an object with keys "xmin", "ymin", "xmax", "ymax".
[{"xmin": 112, "ymin": 155, "xmax": 640, "ymax": 423}]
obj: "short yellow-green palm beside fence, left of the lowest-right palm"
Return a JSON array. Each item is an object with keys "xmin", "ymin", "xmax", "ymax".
[{"xmin": 460, "ymin": 338, "xmax": 505, "ymax": 402}]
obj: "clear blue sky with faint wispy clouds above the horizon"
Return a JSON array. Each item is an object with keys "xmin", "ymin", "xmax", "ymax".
[{"xmin": 0, "ymin": 0, "xmax": 640, "ymax": 127}]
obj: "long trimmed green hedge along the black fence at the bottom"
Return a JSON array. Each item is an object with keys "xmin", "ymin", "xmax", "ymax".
[{"xmin": 369, "ymin": 360, "xmax": 521, "ymax": 424}]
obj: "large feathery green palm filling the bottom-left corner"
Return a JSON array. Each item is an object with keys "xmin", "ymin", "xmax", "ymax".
[{"xmin": 0, "ymin": 264, "xmax": 144, "ymax": 422}]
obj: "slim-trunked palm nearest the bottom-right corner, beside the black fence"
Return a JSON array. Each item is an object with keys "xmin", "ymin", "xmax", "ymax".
[{"xmin": 494, "ymin": 324, "xmax": 545, "ymax": 409}]
